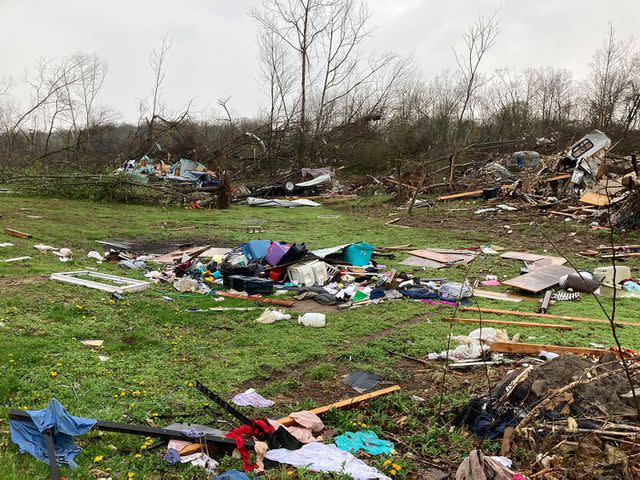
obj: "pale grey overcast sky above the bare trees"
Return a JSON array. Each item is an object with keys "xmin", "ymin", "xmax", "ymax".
[{"xmin": 0, "ymin": 0, "xmax": 640, "ymax": 121}]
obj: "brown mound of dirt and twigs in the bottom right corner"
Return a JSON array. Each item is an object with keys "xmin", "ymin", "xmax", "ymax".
[{"xmin": 459, "ymin": 353, "xmax": 640, "ymax": 478}]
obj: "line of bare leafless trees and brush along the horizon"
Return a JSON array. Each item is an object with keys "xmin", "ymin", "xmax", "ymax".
[{"xmin": 0, "ymin": 0, "xmax": 640, "ymax": 183}]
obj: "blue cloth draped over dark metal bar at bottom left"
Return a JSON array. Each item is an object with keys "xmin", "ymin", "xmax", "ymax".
[{"xmin": 9, "ymin": 398, "xmax": 96, "ymax": 468}]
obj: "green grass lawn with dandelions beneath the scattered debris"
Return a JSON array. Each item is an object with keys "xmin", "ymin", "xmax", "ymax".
[{"xmin": 0, "ymin": 194, "xmax": 640, "ymax": 479}]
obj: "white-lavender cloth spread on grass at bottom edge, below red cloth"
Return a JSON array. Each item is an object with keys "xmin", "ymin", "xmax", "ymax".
[{"xmin": 266, "ymin": 442, "xmax": 390, "ymax": 480}]
